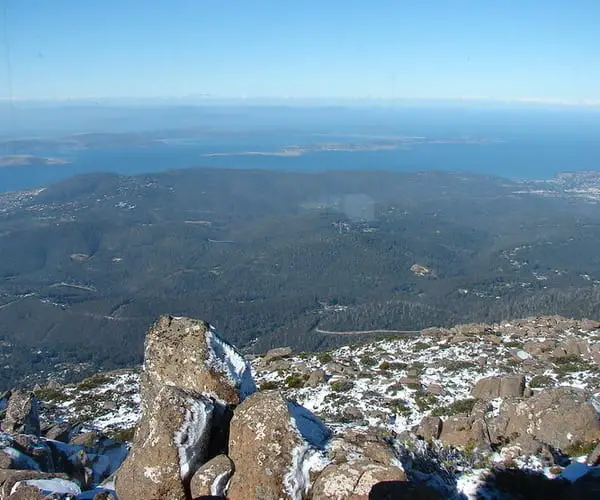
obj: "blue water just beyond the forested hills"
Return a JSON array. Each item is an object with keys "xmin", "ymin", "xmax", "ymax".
[{"xmin": 0, "ymin": 135, "xmax": 600, "ymax": 192}]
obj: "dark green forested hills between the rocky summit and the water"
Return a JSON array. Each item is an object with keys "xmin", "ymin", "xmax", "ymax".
[{"xmin": 0, "ymin": 169, "xmax": 600, "ymax": 389}]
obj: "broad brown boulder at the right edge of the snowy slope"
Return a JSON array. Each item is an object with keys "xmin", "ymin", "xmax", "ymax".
[{"xmin": 493, "ymin": 387, "xmax": 600, "ymax": 450}]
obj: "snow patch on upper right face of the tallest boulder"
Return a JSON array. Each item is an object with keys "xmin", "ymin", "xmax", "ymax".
[{"xmin": 206, "ymin": 326, "xmax": 256, "ymax": 399}]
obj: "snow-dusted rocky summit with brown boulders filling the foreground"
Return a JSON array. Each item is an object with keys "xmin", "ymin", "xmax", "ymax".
[{"xmin": 0, "ymin": 316, "xmax": 600, "ymax": 500}]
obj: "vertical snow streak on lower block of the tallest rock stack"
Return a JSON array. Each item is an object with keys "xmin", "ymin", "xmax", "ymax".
[{"xmin": 173, "ymin": 397, "xmax": 215, "ymax": 479}]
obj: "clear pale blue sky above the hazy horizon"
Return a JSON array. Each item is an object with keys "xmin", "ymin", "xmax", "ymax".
[{"xmin": 0, "ymin": 0, "xmax": 600, "ymax": 101}]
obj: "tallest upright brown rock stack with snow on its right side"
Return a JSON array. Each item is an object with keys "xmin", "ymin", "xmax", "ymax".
[{"xmin": 115, "ymin": 316, "xmax": 255, "ymax": 500}]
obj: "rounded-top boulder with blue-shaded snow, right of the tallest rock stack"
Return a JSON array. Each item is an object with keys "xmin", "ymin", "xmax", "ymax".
[{"xmin": 227, "ymin": 391, "xmax": 329, "ymax": 500}]
